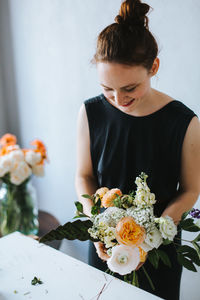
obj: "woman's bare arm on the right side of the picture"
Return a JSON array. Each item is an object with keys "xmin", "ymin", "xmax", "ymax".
[{"xmin": 162, "ymin": 117, "xmax": 200, "ymax": 224}]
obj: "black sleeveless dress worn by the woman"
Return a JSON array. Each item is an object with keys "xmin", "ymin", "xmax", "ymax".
[{"xmin": 84, "ymin": 94, "xmax": 195, "ymax": 300}]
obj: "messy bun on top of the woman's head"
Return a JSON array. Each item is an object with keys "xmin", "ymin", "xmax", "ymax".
[{"xmin": 115, "ymin": 0, "xmax": 150, "ymax": 29}]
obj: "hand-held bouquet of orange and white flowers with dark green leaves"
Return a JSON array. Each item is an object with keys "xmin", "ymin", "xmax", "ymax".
[{"xmin": 40, "ymin": 173, "xmax": 200, "ymax": 289}]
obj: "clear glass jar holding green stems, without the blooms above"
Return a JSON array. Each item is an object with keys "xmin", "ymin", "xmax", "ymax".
[{"xmin": 0, "ymin": 180, "xmax": 39, "ymax": 236}]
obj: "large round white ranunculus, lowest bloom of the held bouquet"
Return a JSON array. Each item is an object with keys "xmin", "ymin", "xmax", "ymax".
[{"xmin": 107, "ymin": 245, "xmax": 140, "ymax": 275}]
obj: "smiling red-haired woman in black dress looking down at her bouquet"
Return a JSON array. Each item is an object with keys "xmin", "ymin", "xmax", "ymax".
[{"xmin": 76, "ymin": 0, "xmax": 200, "ymax": 300}]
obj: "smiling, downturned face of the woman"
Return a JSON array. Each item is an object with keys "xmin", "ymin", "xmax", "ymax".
[{"xmin": 97, "ymin": 62, "xmax": 154, "ymax": 114}]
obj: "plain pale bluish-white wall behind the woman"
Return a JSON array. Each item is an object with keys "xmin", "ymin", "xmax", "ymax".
[{"xmin": 0, "ymin": 0, "xmax": 200, "ymax": 300}]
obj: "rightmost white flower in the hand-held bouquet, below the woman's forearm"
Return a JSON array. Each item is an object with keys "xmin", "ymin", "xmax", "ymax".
[{"xmin": 155, "ymin": 216, "xmax": 177, "ymax": 241}]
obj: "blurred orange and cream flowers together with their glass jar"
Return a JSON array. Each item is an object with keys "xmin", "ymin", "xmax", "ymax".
[{"xmin": 0, "ymin": 134, "xmax": 47, "ymax": 235}]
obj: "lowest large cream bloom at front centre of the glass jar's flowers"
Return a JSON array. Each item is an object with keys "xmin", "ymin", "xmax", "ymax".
[{"xmin": 10, "ymin": 161, "xmax": 32, "ymax": 185}]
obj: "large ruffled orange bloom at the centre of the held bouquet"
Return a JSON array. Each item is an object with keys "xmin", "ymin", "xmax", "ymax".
[{"xmin": 115, "ymin": 217, "xmax": 145, "ymax": 247}]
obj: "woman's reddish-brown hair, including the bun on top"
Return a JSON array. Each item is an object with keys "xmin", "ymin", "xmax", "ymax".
[{"xmin": 92, "ymin": 0, "xmax": 158, "ymax": 70}]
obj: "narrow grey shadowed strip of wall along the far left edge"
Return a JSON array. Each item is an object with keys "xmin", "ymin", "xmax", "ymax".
[{"xmin": 0, "ymin": 1, "xmax": 20, "ymax": 143}]
